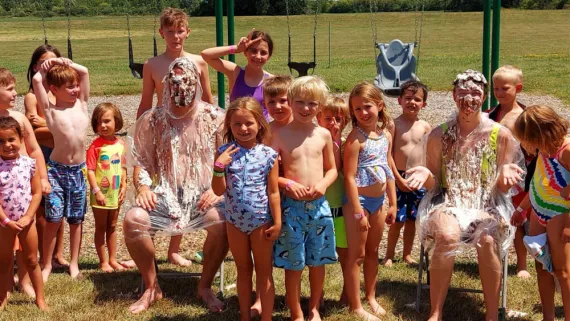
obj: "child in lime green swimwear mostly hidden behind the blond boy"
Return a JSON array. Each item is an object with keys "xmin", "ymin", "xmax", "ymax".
[{"xmin": 317, "ymin": 97, "xmax": 350, "ymax": 304}]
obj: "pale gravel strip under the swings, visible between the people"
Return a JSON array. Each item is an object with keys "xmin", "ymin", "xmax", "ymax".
[{"xmin": 11, "ymin": 92, "xmax": 570, "ymax": 259}]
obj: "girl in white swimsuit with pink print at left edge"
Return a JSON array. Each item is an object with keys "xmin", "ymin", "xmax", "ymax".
[{"xmin": 0, "ymin": 117, "xmax": 48, "ymax": 310}]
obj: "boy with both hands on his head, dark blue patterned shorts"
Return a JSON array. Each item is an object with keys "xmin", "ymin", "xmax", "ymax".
[{"xmin": 32, "ymin": 58, "xmax": 90, "ymax": 282}]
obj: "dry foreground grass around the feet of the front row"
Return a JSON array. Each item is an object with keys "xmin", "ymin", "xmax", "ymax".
[{"xmin": 0, "ymin": 260, "xmax": 563, "ymax": 321}]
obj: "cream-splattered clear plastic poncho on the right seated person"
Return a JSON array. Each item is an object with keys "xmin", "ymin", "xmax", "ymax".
[{"xmin": 408, "ymin": 115, "xmax": 523, "ymax": 257}]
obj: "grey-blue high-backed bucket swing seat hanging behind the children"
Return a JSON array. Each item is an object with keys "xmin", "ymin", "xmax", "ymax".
[{"xmin": 374, "ymin": 39, "xmax": 419, "ymax": 96}]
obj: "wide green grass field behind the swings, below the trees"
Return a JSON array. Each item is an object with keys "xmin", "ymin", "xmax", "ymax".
[{"xmin": 0, "ymin": 10, "xmax": 570, "ymax": 104}]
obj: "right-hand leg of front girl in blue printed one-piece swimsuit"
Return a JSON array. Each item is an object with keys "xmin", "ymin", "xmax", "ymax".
[{"xmin": 249, "ymin": 224, "xmax": 275, "ymax": 321}]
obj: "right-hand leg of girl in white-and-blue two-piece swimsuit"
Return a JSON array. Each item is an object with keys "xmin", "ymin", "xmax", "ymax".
[{"xmin": 364, "ymin": 206, "xmax": 386, "ymax": 315}]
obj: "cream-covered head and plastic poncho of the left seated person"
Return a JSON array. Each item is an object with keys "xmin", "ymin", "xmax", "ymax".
[{"xmin": 128, "ymin": 58, "xmax": 224, "ymax": 235}]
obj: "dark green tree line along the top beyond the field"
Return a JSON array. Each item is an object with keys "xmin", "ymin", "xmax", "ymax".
[{"xmin": 0, "ymin": 0, "xmax": 570, "ymax": 17}]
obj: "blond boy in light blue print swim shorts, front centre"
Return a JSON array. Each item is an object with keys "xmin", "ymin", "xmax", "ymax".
[{"xmin": 273, "ymin": 76, "xmax": 337, "ymax": 320}]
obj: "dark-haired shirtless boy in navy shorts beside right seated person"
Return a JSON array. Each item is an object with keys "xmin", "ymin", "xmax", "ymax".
[{"xmin": 382, "ymin": 81, "xmax": 431, "ymax": 267}]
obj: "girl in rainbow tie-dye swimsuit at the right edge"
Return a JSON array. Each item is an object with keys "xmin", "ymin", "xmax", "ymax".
[{"xmin": 514, "ymin": 106, "xmax": 570, "ymax": 320}]
